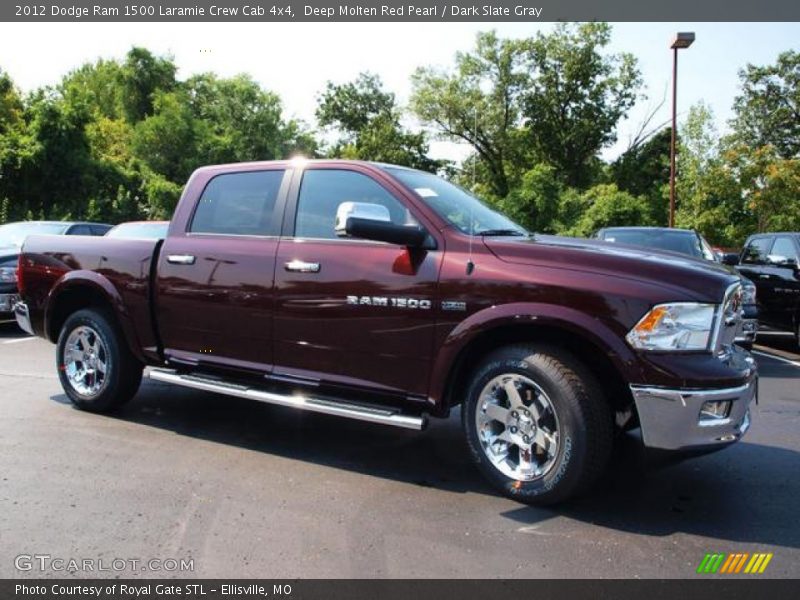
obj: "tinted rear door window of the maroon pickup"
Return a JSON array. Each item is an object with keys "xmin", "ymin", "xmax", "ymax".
[{"xmin": 189, "ymin": 171, "xmax": 284, "ymax": 235}]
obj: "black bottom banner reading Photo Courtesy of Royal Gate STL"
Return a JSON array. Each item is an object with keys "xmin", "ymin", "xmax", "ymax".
[{"xmin": 0, "ymin": 577, "xmax": 800, "ymax": 600}]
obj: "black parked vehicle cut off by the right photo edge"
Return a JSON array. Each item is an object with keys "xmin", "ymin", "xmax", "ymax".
[{"xmin": 730, "ymin": 232, "xmax": 800, "ymax": 345}]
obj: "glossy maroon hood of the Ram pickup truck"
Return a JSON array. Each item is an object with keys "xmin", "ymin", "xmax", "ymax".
[{"xmin": 484, "ymin": 235, "xmax": 739, "ymax": 302}]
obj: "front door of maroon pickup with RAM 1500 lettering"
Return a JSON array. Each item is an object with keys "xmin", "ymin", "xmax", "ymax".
[{"xmin": 274, "ymin": 165, "xmax": 443, "ymax": 399}]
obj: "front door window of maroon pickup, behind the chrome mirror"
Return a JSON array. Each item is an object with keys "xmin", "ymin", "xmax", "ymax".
[{"xmin": 294, "ymin": 169, "xmax": 416, "ymax": 239}]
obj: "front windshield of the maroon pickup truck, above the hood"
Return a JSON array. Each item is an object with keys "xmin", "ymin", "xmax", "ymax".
[{"xmin": 386, "ymin": 167, "xmax": 528, "ymax": 235}]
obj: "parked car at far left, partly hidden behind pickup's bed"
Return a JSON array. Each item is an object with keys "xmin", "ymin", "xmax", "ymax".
[{"xmin": 0, "ymin": 221, "xmax": 111, "ymax": 320}]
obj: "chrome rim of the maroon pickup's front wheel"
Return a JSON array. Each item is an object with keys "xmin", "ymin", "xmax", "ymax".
[{"xmin": 475, "ymin": 373, "xmax": 560, "ymax": 481}]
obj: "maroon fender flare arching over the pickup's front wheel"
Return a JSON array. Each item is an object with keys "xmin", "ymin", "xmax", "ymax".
[{"xmin": 429, "ymin": 302, "xmax": 638, "ymax": 407}]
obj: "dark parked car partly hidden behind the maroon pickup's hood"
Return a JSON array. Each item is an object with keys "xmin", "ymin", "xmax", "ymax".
[{"xmin": 595, "ymin": 227, "xmax": 758, "ymax": 350}]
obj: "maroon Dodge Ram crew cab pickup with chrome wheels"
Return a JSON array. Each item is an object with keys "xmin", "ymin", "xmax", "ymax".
[{"xmin": 16, "ymin": 160, "xmax": 757, "ymax": 504}]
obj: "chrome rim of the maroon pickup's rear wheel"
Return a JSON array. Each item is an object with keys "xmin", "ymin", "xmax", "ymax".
[{"xmin": 64, "ymin": 325, "xmax": 108, "ymax": 398}]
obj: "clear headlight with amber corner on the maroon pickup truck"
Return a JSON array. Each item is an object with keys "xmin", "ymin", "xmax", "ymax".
[{"xmin": 625, "ymin": 302, "xmax": 717, "ymax": 350}]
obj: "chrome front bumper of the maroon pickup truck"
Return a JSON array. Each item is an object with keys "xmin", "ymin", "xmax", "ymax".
[{"xmin": 630, "ymin": 380, "xmax": 758, "ymax": 450}]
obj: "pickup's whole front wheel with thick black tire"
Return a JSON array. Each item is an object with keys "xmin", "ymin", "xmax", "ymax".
[{"xmin": 462, "ymin": 345, "xmax": 614, "ymax": 505}]
